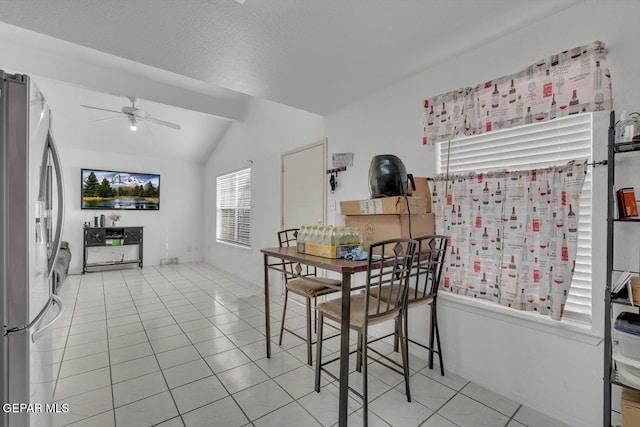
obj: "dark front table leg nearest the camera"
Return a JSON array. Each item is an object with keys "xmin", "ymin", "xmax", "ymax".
[{"xmin": 338, "ymin": 273, "xmax": 351, "ymax": 427}]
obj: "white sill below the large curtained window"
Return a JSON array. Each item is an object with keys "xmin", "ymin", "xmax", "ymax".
[{"xmin": 438, "ymin": 292, "xmax": 603, "ymax": 346}]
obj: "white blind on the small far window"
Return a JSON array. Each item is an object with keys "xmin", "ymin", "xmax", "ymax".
[{"xmin": 216, "ymin": 168, "xmax": 251, "ymax": 247}]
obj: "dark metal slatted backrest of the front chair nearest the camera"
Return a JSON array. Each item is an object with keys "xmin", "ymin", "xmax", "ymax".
[{"xmin": 364, "ymin": 238, "xmax": 417, "ymax": 322}]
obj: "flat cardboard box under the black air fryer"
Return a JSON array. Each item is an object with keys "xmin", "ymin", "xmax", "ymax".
[{"xmin": 340, "ymin": 196, "xmax": 431, "ymax": 215}]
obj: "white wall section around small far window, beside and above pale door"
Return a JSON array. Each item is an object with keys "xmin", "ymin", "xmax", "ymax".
[{"xmin": 205, "ymin": 99, "xmax": 324, "ymax": 284}]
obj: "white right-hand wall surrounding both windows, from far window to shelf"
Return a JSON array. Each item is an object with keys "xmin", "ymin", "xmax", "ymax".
[{"xmin": 206, "ymin": 0, "xmax": 640, "ymax": 427}]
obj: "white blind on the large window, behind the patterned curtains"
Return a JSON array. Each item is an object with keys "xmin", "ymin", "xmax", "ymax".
[{"xmin": 436, "ymin": 114, "xmax": 593, "ymax": 323}]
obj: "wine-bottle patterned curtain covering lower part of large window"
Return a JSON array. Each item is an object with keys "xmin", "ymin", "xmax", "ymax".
[{"xmin": 432, "ymin": 160, "xmax": 587, "ymax": 320}]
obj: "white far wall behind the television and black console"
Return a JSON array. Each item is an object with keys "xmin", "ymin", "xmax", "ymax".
[{"xmin": 56, "ymin": 147, "xmax": 204, "ymax": 273}]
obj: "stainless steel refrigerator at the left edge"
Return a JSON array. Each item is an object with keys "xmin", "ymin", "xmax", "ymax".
[{"xmin": 0, "ymin": 71, "xmax": 64, "ymax": 427}]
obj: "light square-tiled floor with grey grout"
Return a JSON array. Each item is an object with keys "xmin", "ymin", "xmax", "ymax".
[{"xmin": 48, "ymin": 262, "xmax": 564, "ymax": 427}]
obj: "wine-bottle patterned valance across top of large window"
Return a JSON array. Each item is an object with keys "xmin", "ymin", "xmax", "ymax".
[{"xmin": 422, "ymin": 41, "xmax": 613, "ymax": 144}]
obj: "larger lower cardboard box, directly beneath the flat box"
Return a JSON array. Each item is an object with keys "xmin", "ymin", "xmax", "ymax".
[{"xmin": 346, "ymin": 213, "xmax": 436, "ymax": 251}]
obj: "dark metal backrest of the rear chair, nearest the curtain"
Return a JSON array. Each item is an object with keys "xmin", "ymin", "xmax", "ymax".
[{"xmin": 407, "ymin": 235, "xmax": 449, "ymax": 303}]
